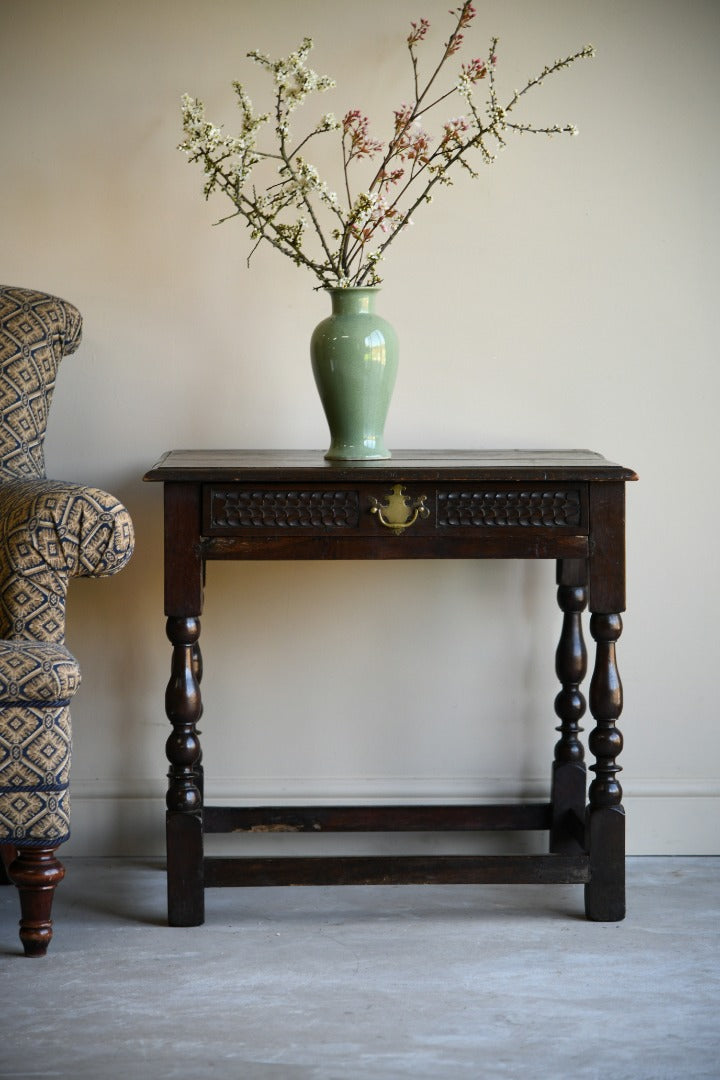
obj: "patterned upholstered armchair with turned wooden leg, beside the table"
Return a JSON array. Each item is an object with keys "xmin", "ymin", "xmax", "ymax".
[{"xmin": 0, "ymin": 286, "xmax": 134, "ymax": 956}]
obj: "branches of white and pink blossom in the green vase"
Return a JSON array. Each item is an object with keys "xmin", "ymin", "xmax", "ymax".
[{"xmin": 179, "ymin": 0, "xmax": 594, "ymax": 288}]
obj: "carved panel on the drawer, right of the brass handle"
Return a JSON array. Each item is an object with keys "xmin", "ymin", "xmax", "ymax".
[{"xmin": 437, "ymin": 485, "xmax": 587, "ymax": 531}]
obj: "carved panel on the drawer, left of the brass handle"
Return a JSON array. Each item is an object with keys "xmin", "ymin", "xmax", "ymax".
[{"xmin": 203, "ymin": 484, "xmax": 359, "ymax": 536}]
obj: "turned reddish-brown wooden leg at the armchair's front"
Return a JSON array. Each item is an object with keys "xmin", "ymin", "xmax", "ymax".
[{"xmin": 8, "ymin": 848, "xmax": 65, "ymax": 956}]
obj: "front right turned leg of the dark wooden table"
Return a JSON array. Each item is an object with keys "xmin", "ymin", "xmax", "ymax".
[{"xmin": 585, "ymin": 613, "xmax": 625, "ymax": 922}]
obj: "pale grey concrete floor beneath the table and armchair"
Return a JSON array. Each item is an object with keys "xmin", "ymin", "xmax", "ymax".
[{"xmin": 0, "ymin": 858, "xmax": 720, "ymax": 1080}]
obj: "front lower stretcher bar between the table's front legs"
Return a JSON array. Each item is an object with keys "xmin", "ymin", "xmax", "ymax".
[{"xmin": 205, "ymin": 855, "xmax": 588, "ymax": 888}]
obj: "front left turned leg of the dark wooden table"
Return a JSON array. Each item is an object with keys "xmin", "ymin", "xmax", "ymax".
[{"xmin": 165, "ymin": 617, "xmax": 205, "ymax": 927}]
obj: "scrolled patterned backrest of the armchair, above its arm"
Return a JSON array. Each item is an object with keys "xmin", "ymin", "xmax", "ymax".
[{"xmin": 0, "ymin": 285, "xmax": 82, "ymax": 484}]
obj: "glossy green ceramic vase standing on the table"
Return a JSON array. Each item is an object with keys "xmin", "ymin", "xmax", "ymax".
[{"xmin": 310, "ymin": 287, "xmax": 397, "ymax": 461}]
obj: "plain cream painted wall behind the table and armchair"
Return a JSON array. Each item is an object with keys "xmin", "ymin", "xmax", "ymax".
[{"xmin": 0, "ymin": 0, "xmax": 720, "ymax": 854}]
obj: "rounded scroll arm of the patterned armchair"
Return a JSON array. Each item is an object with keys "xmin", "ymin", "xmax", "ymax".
[{"xmin": 0, "ymin": 480, "xmax": 134, "ymax": 643}]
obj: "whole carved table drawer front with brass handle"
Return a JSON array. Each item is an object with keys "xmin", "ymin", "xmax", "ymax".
[{"xmin": 202, "ymin": 481, "xmax": 587, "ymax": 537}]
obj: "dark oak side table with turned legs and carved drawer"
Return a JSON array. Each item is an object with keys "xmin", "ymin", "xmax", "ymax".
[{"xmin": 145, "ymin": 450, "xmax": 637, "ymax": 926}]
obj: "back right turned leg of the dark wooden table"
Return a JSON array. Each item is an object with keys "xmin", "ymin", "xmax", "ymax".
[{"xmin": 549, "ymin": 561, "xmax": 587, "ymax": 855}]
